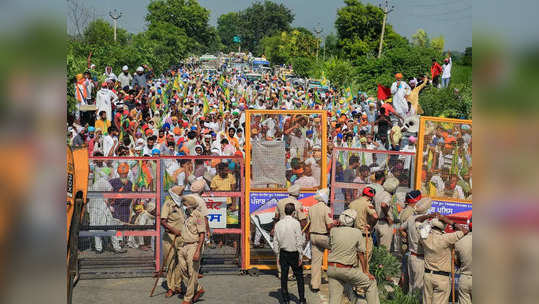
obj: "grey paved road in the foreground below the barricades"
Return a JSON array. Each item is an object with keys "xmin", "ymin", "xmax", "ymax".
[{"xmin": 73, "ymin": 274, "xmax": 327, "ymax": 304}]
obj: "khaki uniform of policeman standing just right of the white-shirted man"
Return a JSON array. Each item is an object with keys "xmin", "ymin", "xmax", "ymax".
[{"xmin": 309, "ymin": 202, "xmax": 333, "ymax": 289}]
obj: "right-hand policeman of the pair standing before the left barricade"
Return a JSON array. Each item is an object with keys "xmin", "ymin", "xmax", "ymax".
[{"xmin": 178, "ymin": 195, "xmax": 206, "ymax": 304}]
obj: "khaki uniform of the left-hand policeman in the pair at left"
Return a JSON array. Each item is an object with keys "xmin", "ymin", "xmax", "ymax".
[{"xmin": 161, "ymin": 199, "xmax": 185, "ymax": 290}]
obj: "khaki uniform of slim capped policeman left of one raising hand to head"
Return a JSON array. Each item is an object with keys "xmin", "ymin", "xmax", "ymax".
[{"xmin": 400, "ymin": 215, "xmax": 425, "ymax": 293}]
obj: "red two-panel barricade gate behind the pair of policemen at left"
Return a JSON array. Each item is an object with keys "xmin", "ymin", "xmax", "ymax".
[{"xmin": 79, "ymin": 156, "xmax": 245, "ymax": 279}]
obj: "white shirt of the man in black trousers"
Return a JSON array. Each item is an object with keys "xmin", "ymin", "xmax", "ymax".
[{"xmin": 273, "ymin": 215, "xmax": 305, "ymax": 253}]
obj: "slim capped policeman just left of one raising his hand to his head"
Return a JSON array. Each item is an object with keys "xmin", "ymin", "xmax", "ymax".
[{"xmin": 399, "ymin": 197, "xmax": 436, "ymax": 293}]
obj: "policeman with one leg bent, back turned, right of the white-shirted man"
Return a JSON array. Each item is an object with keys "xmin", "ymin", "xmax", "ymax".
[{"xmin": 328, "ymin": 209, "xmax": 380, "ymax": 304}]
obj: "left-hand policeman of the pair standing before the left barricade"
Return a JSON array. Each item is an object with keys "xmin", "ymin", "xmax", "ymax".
[{"xmin": 161, "ymin": 186, "xmax": 185, "ymax": 298}]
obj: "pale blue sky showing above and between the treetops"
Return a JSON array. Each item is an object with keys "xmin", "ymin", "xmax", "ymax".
[{"xmin": 67, "ymin": 0, "xmax": 472, "ymax": 51}]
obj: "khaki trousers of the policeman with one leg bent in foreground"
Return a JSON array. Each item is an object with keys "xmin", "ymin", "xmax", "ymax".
[{"xmin": 328, "ymin": 266, "xmax": 380, "ymax": 304}]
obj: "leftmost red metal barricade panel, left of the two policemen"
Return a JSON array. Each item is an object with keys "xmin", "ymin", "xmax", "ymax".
[{"xmin": 79, "ymin": 157, "xmax": 161, "ymax": 279}]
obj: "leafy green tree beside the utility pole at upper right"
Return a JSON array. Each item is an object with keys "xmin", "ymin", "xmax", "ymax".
[{"xmin": 335, "ymin": 0, "xmax": 407, "ymax": 59}]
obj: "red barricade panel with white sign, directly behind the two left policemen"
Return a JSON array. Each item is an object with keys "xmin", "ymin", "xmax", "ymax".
[{"xmin": 160, "ymin": 156, "xmax": 246, "ymax": 273}]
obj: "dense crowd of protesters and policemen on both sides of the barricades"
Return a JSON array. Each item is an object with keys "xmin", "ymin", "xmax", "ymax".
[{"xmin": 67, "ymin": 51, "xmax": 472, "ymax": 303}]
